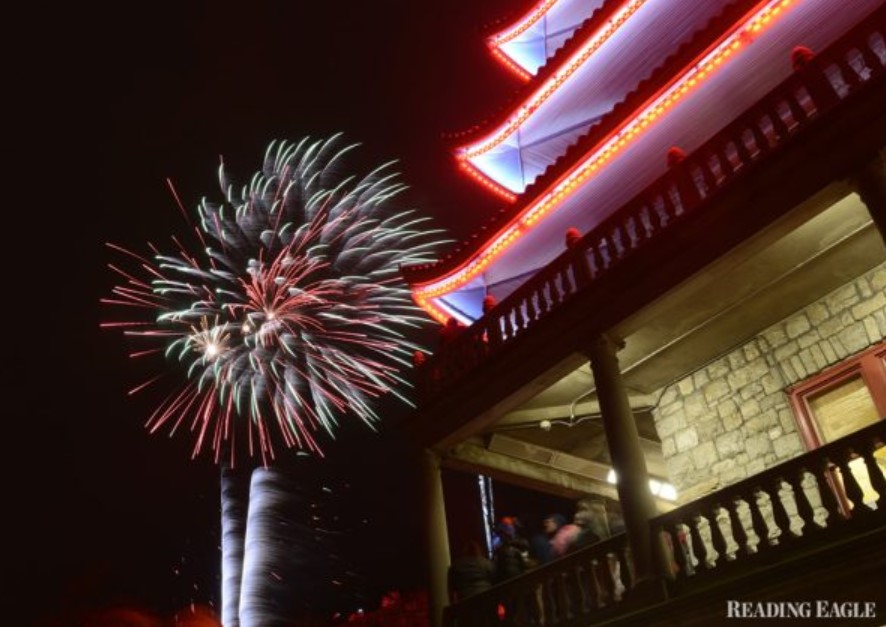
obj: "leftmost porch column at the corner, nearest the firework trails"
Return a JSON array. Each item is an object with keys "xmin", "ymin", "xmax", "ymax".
[{"xmin": 422, "ymin": 449, "xmax": 449, "ymax": 627}]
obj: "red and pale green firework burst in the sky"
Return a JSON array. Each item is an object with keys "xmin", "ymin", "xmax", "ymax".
[{"xmin": 103, "ymin": 135, "xmax": 443, "ymax": 464}]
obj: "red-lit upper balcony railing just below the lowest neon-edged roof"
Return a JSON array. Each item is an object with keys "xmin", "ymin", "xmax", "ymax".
[{"xmin": 416, "ymin": 13, "xmax": 886, "ymax": 399}]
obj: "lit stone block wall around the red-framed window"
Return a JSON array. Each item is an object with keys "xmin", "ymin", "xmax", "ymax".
[{"xmin": 653, "ymin": 264, "xmax": 886, "ymax": 500}]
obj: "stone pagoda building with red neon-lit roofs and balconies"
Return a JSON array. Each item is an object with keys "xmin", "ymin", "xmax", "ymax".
[{"xmin": 402, "ymin": 0, "xmax": 886, "ymax": 627}]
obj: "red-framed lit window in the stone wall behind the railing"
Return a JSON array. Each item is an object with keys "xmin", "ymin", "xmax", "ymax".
[{"xmin": 788, "ymin": 343, "xmax": 886, "ymax": 508}]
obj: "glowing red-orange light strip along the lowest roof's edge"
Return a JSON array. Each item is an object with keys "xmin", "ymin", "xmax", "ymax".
[{"xmin": 413, "ymin": 0, "xmax": 795, "ymax": 321}]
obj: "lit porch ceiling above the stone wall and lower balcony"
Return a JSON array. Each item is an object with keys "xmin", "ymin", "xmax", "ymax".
[{"xmin": 464, "ymin": 184, "xmax": 886, "ymax": 500}]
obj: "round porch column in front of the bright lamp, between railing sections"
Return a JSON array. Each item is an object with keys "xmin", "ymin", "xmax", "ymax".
[{"xmin": 588, "ymin": 334, "xmax": 658, "ymax": 581}]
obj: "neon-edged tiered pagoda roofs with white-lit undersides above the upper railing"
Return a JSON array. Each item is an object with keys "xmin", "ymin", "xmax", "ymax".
[{"xmin": 407, "ymin": 0, "xmax": 880, "ymax": 322}]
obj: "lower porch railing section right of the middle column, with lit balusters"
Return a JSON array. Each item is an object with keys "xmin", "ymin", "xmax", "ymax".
[{"xmin": 653, "ymin": 420, "xmax": 886, "ymax": 593}]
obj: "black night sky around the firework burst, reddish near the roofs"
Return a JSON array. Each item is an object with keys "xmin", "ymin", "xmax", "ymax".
[{"xmin": 13, "ymin": 0, "xmax": 533, "ymax": 625}]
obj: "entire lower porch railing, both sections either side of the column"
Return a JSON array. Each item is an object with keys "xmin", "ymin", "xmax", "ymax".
[{"xmin": 444, "ymin": 420, "xmax": 886, "ymax": 627}]
